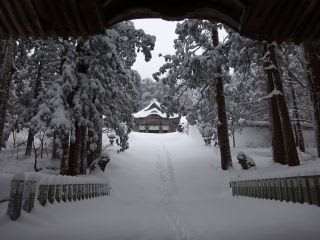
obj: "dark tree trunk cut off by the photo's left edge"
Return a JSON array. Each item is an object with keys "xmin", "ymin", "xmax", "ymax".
[{"xmin": 0, "ymin": 40, "xmax": 15, "ymax": 150}]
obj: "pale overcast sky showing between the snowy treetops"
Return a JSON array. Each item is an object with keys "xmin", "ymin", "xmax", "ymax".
[{"xmin": 133, "ymin": 19, "xmax": 226, "ymax": 79}]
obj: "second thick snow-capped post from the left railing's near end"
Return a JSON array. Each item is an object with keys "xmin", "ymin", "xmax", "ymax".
[{"xmin": 22, "ymin": 174, "xmax": 38, "ymax": 213}]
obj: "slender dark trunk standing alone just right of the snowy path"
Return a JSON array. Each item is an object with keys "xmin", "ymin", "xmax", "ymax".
[{"xmin": 212, "ymin": 25, "xmax": 232, "ymax": 170}]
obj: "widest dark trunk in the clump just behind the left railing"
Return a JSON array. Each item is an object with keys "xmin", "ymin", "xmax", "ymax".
[{"xmin": 69, "ymin": 122, "xmax": 82, "ymax": 176}]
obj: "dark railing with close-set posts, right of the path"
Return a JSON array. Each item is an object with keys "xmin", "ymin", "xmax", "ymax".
[{"xmin": 230, "ymin": 175, "xmax": 320, "ymax": 206}]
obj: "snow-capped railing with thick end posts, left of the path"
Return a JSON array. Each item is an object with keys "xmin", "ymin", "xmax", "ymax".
[{"xmin": 7, "ymin": 173, "xmax": 110, "ymax": 220}]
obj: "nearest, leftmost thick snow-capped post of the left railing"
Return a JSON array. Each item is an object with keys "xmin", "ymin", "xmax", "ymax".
[{"xmin": 7, "ymin": 173, "xmax": 25, "ymax": 220}]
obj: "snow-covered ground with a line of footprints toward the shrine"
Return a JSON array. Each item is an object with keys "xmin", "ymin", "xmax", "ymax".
[{"xmin": 0, "ymin": 127, "xmax": 320, "ymax": 240}]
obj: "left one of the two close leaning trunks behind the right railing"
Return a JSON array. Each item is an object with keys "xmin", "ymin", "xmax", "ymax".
[{"xmin": 264, "ymin": 44, "xmax": 287, "ymax": 165}]
